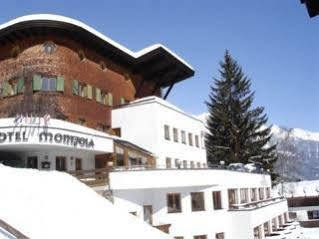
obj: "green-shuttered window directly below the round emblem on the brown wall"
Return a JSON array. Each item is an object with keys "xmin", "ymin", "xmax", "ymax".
[{"xmin": 32, "ymin": 75, "xmax": 64, "ymax": 92}]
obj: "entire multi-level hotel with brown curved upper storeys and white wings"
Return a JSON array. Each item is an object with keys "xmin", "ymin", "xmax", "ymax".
[{"xmin": 0, "ymin": 15, "xmax": 299, "ymax": 239}]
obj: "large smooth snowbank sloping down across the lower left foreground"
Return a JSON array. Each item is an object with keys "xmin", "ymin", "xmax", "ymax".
[{"xmin": 0, "ymin": 164, "xmax": 170, "ymax": 239}]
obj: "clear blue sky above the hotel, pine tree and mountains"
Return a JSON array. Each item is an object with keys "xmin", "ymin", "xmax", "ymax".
[{"xmin": 0, "ymin": 0, "xmax": 319, "ymax": 131}]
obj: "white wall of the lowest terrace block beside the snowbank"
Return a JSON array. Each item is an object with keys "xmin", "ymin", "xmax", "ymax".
[{"xmin": 110, "ymin": 169, "xmax": 288, "ymax": 239}]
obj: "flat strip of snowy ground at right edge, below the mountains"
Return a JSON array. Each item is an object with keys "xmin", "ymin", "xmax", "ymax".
[{"xmin": 274, "ymin": 180, "xmax": 319, "ymax": 196}]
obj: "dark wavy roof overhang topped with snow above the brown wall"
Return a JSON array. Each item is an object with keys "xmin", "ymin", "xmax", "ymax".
[{"xmin": 0, "ymin": 14, "xmax": 194, "ymax": 87}]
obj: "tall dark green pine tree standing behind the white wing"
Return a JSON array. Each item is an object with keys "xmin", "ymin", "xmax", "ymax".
[{"xmin": 206, "ymin": 51, "xmax": 276, "ymax": 178}]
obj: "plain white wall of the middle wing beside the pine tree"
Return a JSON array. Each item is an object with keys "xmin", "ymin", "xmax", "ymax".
[{"xmin": 112, "ymin": 97, "xmax": 206, "ymax": 168}]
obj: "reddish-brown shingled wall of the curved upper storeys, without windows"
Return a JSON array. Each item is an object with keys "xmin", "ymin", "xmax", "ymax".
[{"xmin": 0, "ymin": 35, "xmax": 159, "ymax": 131}]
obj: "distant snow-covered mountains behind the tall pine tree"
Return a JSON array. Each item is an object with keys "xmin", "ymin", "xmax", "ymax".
[{"xmin": 197, "ymin": 113, "xmax": 319, "ymax": 180}]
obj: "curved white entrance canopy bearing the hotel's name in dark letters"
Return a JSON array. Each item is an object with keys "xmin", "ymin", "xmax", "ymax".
[{"xmin": 0, "ymin": 116, "xmax": 114, "ymax": 154}]
